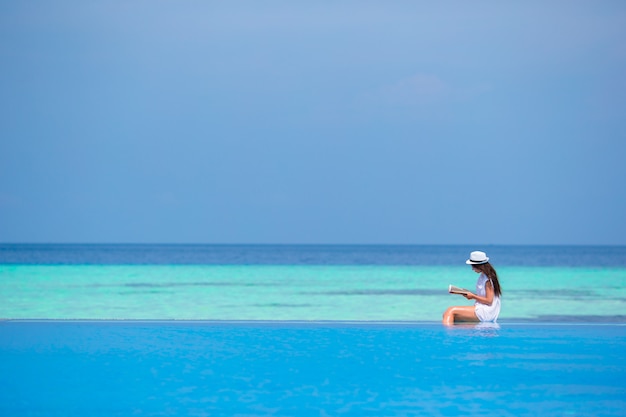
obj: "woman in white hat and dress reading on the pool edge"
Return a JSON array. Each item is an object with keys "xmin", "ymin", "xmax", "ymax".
[{"xmin": 443, "ymin": 251, "xmax": 502, "ymax": 324}]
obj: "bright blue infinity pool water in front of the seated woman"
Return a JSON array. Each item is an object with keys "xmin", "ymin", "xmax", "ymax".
[{"xmin": 0, "ymin": 320, "xmax": 626, "ymax": 417}]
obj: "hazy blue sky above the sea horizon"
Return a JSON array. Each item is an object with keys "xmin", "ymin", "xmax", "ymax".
[{"xmin": 0, "ymin": 0, "xmax": 626, "ymax": 245}]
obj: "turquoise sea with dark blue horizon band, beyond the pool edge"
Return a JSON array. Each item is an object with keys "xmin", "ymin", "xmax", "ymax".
[{"xmin": 0, "ymin": 244, "xmax": 626, "ymax": 321}]
